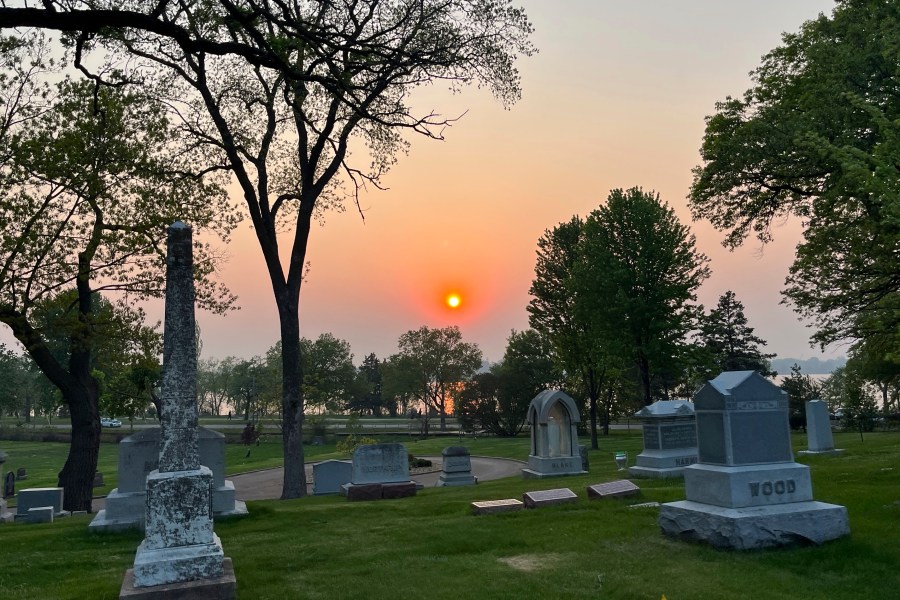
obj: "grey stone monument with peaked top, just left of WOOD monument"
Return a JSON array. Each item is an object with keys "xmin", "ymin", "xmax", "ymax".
[{"xmin": 628, "ymin": 400, "xmax": 697, "ymax": 478}]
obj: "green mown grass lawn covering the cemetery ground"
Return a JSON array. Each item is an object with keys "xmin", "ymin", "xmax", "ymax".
[{"xmin": 0, "ymin": 432, "xmax": 900, "ymax": 600}]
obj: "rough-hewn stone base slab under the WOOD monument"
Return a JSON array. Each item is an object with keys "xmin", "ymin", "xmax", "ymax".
[{"xmin": 659, "ymin": 500, "xmax": 850, "ymax": 550}]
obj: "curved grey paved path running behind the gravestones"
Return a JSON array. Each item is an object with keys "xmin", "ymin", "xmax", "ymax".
[{"xmin": 228, "ymin": 456, "xmax": 525, "ymax": 501}]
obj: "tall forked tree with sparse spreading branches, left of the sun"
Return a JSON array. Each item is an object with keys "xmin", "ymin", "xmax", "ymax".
[{"xmin": 0, "ymin": 0, "xmax": 534, "ymax": 498}]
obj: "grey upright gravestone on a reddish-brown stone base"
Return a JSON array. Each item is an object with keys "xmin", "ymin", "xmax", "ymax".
[{"xmin": 341, "ymin": 444, "xmax": 417, "ymax": 500}]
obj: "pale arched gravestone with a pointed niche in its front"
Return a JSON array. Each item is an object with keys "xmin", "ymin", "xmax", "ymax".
[{"xmin": 522, "ymin": 390, "xmax": 587, "ymax": 479}]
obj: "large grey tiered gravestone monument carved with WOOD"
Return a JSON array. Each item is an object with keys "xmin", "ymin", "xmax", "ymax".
[{"xmin": 659, "ymin": 371, "xmax": 850, "ymax": 550}]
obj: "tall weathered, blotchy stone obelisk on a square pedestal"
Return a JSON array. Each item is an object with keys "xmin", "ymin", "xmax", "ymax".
[{"xmin": 119, "ymin": 222, "xmax": 235, "ymax": 598}]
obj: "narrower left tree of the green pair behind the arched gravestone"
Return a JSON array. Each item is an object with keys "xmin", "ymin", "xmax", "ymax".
[{"xmin": 528, "ymin": 215, "xmax": 617, "ymax": 449}]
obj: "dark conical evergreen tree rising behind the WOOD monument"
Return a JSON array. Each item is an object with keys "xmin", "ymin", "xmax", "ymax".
[{"xmin": 698, "ymin": 290, "xmax": 776, "ymax": 379}]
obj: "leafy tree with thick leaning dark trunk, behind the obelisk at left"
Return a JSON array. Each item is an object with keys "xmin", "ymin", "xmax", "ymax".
[{"xmin": 0, "ymin": 50, "xmax": 233, "ymax": 511}]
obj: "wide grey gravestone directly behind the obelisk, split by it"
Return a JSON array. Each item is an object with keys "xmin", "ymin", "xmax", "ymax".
[{"xmin": 88, "ymin": 427, "xmax": 247, "ymax": 531}]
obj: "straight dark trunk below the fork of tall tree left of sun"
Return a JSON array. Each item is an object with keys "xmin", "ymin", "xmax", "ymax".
[{"xmin": 276, "ymin": 294, "xmax": 306, "ymax": 500}]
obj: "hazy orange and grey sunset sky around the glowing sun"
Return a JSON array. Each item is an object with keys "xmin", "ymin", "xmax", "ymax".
[{"xmin": 4, "ymin": 0, "xmax": 845, "ymax": 364}]
